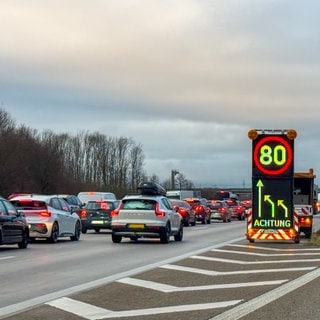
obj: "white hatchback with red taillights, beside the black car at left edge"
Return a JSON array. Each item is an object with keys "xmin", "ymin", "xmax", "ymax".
[{"xmin": 10, "ymin": 194, "xmax": 81, "ymax": 243}]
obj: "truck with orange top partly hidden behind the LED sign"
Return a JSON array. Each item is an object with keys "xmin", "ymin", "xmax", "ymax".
[{"xmin": 293, "ymin": 168, "xmax": 316, "ymax": 239}]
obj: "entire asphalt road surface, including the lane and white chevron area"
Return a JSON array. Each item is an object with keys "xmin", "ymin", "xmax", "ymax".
[{"xmin": 0, "ymin": 217, "xmax": 320, "ymax": 320}]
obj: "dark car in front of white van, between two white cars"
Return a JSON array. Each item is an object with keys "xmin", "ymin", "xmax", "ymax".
[{"xmin": 80, "ymin": 200, "xmax": 120, "ymax": 233}]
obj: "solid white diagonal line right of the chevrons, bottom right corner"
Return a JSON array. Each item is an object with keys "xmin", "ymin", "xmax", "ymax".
[{"xmin": 210, "ymin": 268, "xmax": 320, "ymax": 320}]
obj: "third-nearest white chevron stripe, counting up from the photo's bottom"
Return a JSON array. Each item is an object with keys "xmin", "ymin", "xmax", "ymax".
[{"xmin": 159, "ymin": 264, "xmax": 317, "ymax": 276}]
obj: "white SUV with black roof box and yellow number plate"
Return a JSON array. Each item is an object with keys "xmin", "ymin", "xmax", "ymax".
[{"xmin": 111, "ymin": 181, "xmax": 183, "ymax": 243}]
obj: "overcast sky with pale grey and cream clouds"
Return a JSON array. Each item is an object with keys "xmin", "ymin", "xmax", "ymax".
[{"xmin": 0, "ymin": 0, "xmax": 320, "ymax": 187}]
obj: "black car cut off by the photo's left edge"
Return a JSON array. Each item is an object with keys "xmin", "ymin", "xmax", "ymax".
[{"xmin": 0, "ymin": 197, "xmax": 29, "ymax": 249}]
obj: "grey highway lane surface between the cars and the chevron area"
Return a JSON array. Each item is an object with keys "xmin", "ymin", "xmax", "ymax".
[{"xmin": 0, "ymin": 221, "xmax": 246, "ymax": 311}]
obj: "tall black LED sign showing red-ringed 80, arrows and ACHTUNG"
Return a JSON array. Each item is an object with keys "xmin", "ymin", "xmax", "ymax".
[{"xmin": 248, "ymin": 129, "xmax": 296, "ymax": 234}]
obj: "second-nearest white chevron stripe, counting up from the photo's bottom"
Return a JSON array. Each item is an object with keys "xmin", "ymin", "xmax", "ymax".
[{"xmin": 117, "ymin": 278, "xmax": 288, "ymax": 293}]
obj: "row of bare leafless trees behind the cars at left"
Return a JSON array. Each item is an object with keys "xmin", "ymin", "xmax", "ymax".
[{"xmin": 0, "ymin": 108, "xmax": 146, "ymax": 197}]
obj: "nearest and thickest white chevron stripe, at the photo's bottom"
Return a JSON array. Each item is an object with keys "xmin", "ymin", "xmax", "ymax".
[{"xmin": 46, "ymin": 298, "xmax": 242, "ymax": 320}]
